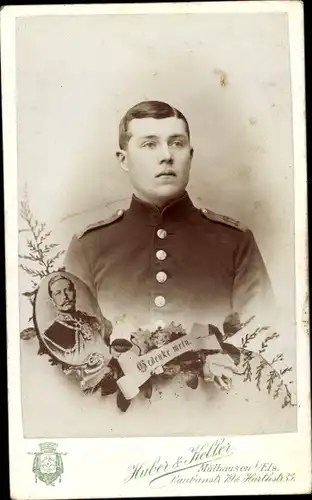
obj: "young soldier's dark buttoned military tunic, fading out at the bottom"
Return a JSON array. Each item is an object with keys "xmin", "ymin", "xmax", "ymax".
[{"xmin": 65, "ymin": 193, "xmax": 271, "ymax": 333}]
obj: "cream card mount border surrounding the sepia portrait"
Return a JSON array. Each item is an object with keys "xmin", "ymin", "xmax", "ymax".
[{"xmin": 1, "ymin": 1, "xmax": 311, "ymax": 500}]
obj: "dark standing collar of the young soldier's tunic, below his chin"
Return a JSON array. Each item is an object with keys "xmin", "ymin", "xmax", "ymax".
[{"xmin": 127, "ymin": 191, "xmax": 197, "ymax": 225}]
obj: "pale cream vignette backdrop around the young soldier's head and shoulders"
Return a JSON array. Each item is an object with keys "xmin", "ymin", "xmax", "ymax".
[{"xmin": 16, "ymin": 13, "xmax": 296, "ymax": 434}]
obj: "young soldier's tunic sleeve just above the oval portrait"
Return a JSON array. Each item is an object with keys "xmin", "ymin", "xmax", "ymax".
[{"xmin": 64, "ymin": 236, "xmax": 95, "ymax": 295}]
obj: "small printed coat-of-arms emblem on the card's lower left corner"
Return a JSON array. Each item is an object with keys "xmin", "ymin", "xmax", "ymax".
[{"xmin": 33, "ymin": 443, "xmax": 64, "ymax": 486}]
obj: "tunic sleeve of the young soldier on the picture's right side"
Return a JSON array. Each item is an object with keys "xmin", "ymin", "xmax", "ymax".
[{"xmin": 232, "ymin": 230, "xmax": 274, "ymax": 318}]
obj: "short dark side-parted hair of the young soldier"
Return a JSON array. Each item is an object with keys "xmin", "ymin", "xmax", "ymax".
[{"xmin": 119, "ymin": 101, "xmax": 190, "ymax": 150}]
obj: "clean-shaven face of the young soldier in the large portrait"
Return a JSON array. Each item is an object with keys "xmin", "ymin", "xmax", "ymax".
[{"xmin": 119, "ymin": 117, "xmax": 193, "ymax": 206}]
